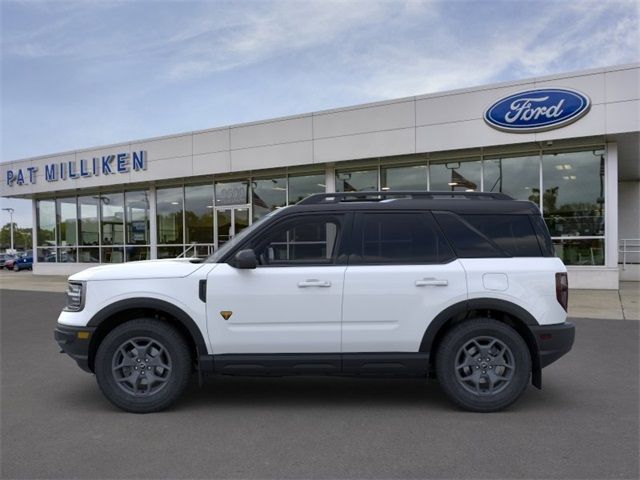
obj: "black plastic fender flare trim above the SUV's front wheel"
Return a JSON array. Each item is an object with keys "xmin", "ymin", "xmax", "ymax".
[{"xmin": 87, "ymin": 298, "xmax": 207, "ymax": 356}]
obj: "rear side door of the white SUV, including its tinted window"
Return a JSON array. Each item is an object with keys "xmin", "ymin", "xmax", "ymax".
[{"xmin": 342, "ymin": 211, "xmax": 467, "ymax": 353}]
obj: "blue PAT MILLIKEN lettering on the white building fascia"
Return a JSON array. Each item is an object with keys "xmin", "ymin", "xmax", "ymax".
[{"xmin": 5, "ymin": 150, "xmax": 147, "ymax": 187}]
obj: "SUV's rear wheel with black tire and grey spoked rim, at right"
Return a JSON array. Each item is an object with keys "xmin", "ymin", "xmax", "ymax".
[{"xmin": 436, "ymin": 318, "xmax": 531, "ymax": 412}]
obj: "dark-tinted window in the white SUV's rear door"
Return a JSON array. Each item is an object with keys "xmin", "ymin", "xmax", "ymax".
[{"xmin": 351, "ymin": 212, "xmax": 454, "ymax": 264}]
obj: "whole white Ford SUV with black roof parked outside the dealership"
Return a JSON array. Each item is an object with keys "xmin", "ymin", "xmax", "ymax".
[{"xmin": 55, "ymin": 192, "xmax": 574, "ymax": 412}]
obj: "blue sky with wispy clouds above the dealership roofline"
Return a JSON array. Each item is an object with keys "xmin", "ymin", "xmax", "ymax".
[{"xmin": 0, "ymin": 0, "xmax": 640, "ymax": 226}]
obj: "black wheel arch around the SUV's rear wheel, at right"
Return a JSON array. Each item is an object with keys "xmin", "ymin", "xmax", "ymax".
[{"xmin": 420, "ymin": 298, "xmax": 542, "ymax": 388}]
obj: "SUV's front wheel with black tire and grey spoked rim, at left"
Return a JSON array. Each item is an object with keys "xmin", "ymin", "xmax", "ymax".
[{"xmin": 95, "ymin": 318, "xmax": 191, "ymax": 413}]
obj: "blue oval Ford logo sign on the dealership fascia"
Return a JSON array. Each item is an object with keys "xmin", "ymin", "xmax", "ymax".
[{"xmin": 484, "ymin": 88, "xmax": 591, "ymax": 133}]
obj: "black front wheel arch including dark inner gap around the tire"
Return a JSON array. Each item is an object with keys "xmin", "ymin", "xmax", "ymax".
[{"xmin": 87, "ymin": 298, "xmax": 207, "ymax": 372}]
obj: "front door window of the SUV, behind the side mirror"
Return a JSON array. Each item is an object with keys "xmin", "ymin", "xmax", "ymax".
[{"xmin": 255, "ymin": 215, "xmax": 341, "ymax": 266}]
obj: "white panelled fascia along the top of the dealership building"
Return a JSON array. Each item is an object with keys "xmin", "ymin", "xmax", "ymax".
[{"xmin": 0, "ymin": 64, "xmax": 640, "ymax": 196}]
